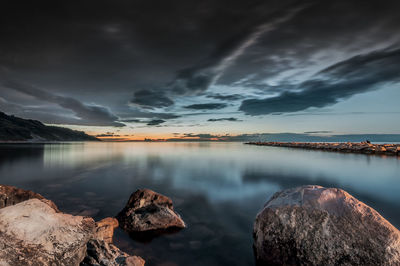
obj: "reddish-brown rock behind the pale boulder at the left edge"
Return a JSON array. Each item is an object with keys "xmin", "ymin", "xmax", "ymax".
[{"xmin": 0, "ymin": 185, "xmax": 59, "ymax": 212}]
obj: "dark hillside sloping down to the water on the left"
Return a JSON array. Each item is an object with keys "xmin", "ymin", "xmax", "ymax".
[{"xmin": 0, "ymin": 112, "xmax": 99, "ymax": 141}]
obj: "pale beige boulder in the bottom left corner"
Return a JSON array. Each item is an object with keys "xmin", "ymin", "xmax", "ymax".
[{"xmin": 0, "ymin": 198, "xmax": 95, "ymax": 265}]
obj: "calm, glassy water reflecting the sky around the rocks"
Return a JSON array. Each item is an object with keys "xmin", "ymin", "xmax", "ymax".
[{"xmin": 0, "ymin": 143, "xmax": 400, "ymax": 265}]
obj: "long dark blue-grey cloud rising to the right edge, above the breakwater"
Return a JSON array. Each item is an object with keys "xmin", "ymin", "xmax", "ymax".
[{"xmin": 239, "ymin": 49, "xmax": 400, "ymax": 115}]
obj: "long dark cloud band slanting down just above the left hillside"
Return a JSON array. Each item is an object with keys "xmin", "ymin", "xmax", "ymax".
[{"xmin": 3, "ymin": 80, "xmax": 125, "ymax": 127}]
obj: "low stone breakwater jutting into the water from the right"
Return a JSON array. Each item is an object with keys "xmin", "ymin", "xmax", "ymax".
[{"xmin": 245, "ymin": 142, "xmax": 400, "ymax": 156}]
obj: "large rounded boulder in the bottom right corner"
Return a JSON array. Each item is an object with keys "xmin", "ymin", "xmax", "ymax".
[{"xmin": 253, "ymin": 186, "xmax": 400, "ymax": 265}]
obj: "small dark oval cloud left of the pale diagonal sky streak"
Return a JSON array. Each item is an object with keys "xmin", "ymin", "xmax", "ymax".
[{"xmin": 130, "ymin": 90, "xmax": 174, "ymax": 109}]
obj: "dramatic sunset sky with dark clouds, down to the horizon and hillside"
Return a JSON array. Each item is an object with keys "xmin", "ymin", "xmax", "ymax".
[{"xmin": 0, "ymin": 0, "xmax": 400, "ymax": 139}]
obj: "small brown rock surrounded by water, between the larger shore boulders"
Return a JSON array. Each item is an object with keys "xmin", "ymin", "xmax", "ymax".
[{"xmin": 117, "ymin": 189, "xmax": 185, "ymax": 233}]
